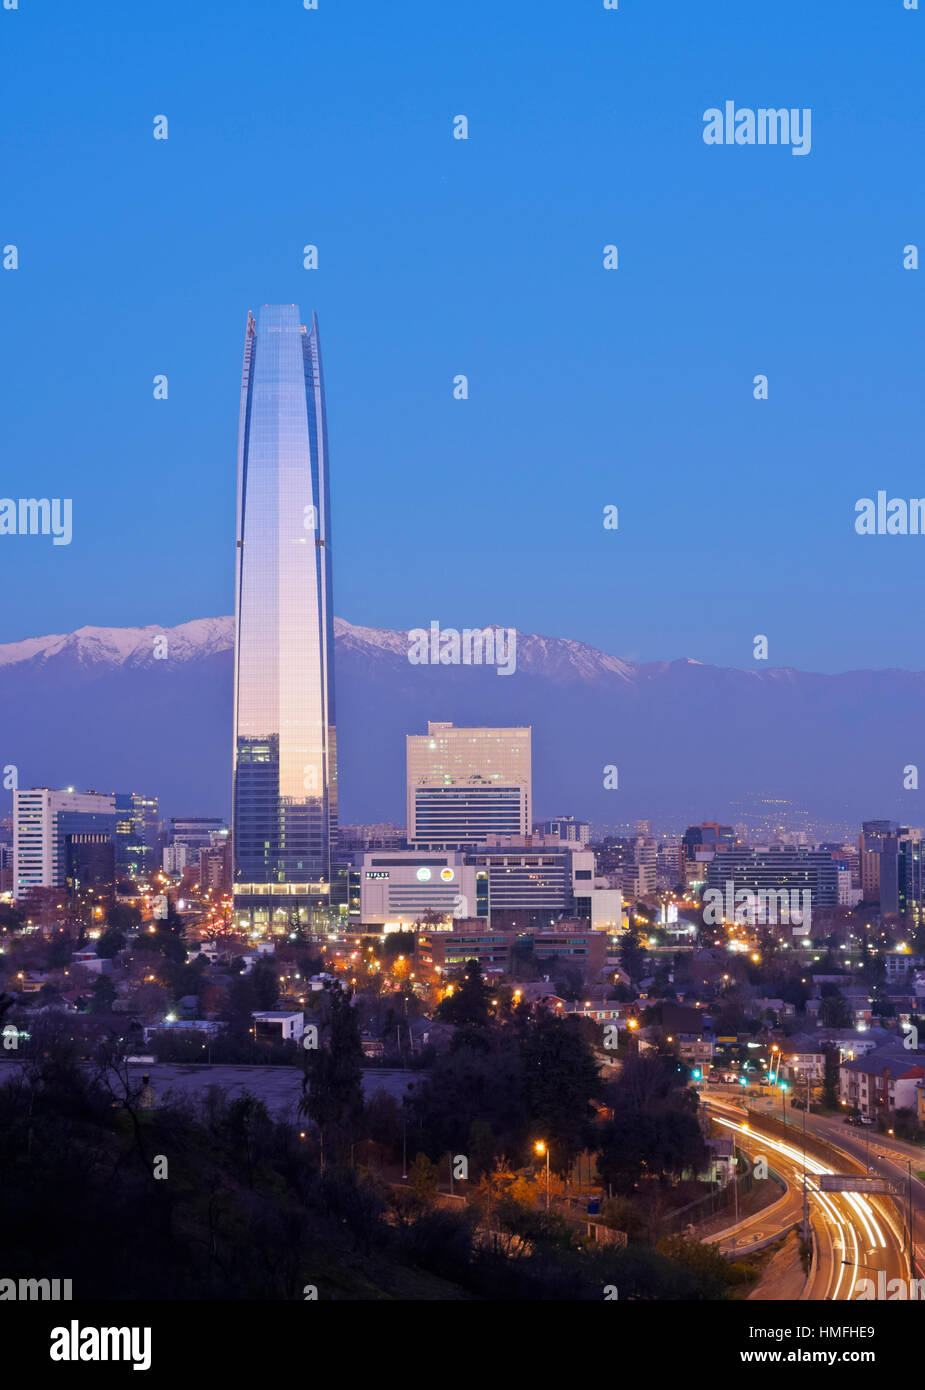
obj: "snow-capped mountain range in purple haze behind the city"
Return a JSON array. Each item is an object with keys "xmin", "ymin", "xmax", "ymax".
[{"xmin": 0, "ymin": 617, "xmax": 925, "ymax": 824}]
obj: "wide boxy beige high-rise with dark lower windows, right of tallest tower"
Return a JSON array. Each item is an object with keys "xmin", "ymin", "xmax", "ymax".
[{"xmin": 408, "ymin": 723, "xmax": 533, "ymax": 849}]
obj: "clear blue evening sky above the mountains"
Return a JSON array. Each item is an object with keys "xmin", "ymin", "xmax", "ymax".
[{"xmin": 0, "ymin": 0, "xmax": 925, "ymax": 670}]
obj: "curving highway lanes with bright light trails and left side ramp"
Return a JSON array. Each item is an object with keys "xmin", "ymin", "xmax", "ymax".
[{"xmin": 702, "ymin": 1094, "xmax": 908, "ymax": 1302}]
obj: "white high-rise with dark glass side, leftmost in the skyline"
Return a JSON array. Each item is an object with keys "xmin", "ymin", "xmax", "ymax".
[{"xmin": 13, "ymin": 787, "xmax": 115, "ymax": 901}]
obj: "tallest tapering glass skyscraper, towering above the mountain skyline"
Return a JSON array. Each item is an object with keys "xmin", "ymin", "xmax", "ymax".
[{"xmin": 232, "ymin": 304, "xmax": 337, "ymax": 929}]
